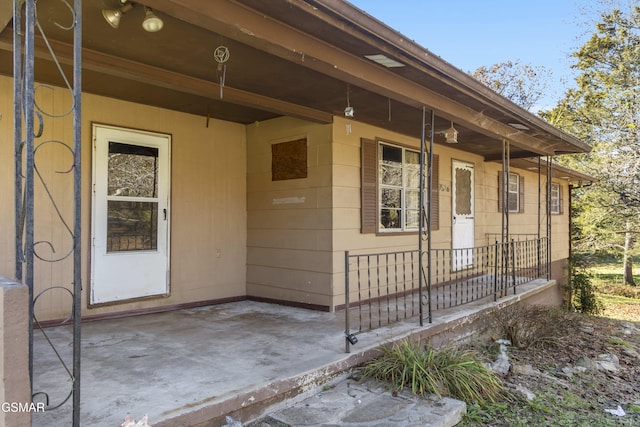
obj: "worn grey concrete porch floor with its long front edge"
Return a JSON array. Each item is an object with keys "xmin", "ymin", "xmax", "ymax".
[{"xmin": 32, "ymin": 280, "xmax": 554, "ymax": 427}]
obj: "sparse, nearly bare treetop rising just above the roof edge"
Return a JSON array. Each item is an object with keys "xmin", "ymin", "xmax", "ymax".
[{"xmin": 472, "ymin": 61, "xmax": 551, "ymax": 110}]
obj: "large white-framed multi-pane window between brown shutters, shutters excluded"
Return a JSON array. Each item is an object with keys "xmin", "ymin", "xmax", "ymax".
[{"xmin": 378, "ymin": 143, "xmax": 420, "ymax": 231}]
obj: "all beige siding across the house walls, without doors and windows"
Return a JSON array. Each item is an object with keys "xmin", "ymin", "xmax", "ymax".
[{"xmin": 0, "ymin": 77, "xmax": 569, "ymax": 320}]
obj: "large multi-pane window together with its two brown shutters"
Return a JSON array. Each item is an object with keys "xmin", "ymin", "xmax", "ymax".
[{"xmin": 361, "ymin": 139, "xmax": 439, "ymax": 233}]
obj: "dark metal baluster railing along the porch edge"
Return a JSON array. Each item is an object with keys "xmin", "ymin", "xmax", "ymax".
[{"xmin": 345, "ymin": 237, "xmax": 549, "ymax": 352}]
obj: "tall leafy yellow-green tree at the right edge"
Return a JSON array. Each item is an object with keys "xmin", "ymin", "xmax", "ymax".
[{"xmin": 542, "ymin": 4, "xmax": 640, "ymax": 284}]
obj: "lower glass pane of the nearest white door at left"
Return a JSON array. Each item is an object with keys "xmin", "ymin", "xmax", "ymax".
[{"xmin": 107, "ymin": 201, "xmax": 158, "ymax": 253}]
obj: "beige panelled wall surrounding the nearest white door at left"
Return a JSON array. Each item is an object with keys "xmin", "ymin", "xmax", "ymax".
[{"xmin": 0, "ymin": 77, "xmax": 246, "ymax": 320}]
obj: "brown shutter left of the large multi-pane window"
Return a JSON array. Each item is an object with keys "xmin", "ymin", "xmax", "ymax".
[{"xmin": 360, "ymin": 138, "xmax": 378, "ymax": 234}]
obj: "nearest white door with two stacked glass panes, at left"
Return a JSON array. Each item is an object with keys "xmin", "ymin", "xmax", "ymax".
[{"xmin": 90, "ymin": 125, "xmax": 171, "ymax": 304}]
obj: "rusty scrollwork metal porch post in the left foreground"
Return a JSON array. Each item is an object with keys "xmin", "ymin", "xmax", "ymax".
[{"xmin": 13, "ymin": 0, "xmax": 82, "ymax": 426}]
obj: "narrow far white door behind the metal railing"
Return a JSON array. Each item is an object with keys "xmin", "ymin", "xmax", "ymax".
[{"xmin": 451, "ymin": 160, "xmax": 475, "ymax": 271}]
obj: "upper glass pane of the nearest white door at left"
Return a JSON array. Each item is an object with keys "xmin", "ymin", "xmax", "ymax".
[{"xmin": 107, "ymin": 142, "xmax": 158, "ymax": 197}]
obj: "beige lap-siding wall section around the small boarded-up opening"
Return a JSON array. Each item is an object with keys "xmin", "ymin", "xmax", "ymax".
[{"xmin": 247, "ymin": 118, "xmax": 334, "ymax": 307}]
